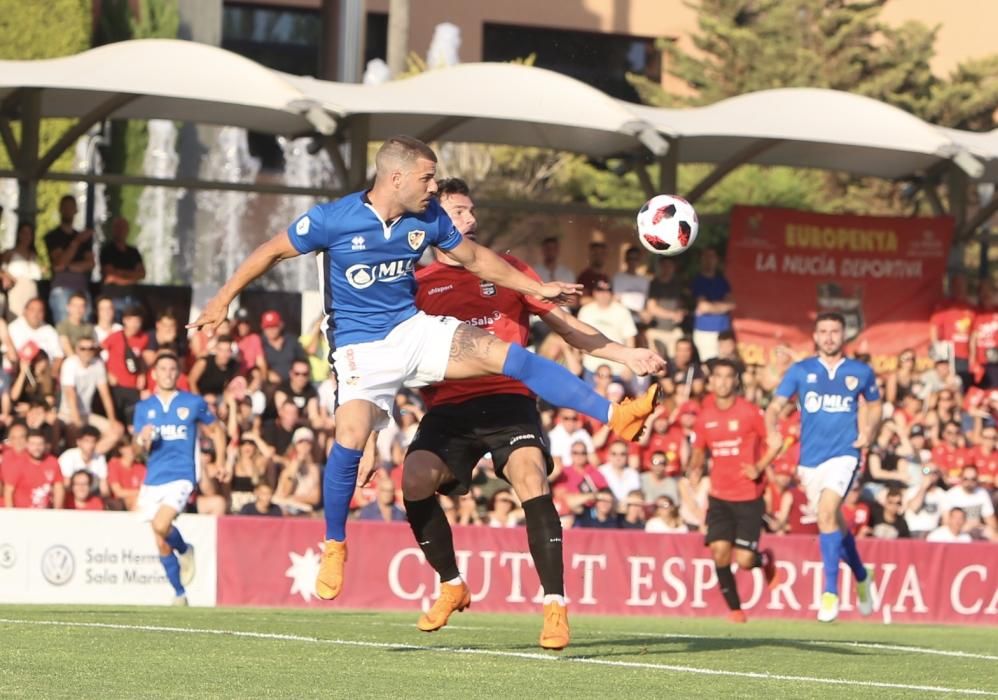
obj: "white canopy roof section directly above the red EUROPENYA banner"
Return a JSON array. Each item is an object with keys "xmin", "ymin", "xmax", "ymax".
[{"xmin": 631, "ymin": 88, "xmax": 980, "ymax": 179}]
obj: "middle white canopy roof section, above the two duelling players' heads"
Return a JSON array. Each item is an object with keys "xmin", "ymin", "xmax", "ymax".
[{"xmin": 287, "ymin": 63, "xmax": 664, "ymax": 156}]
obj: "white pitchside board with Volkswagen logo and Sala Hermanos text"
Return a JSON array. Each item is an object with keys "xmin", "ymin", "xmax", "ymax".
[{"xmin": 0, "ymin": 509, "xmax": 217, "ymax": 606}]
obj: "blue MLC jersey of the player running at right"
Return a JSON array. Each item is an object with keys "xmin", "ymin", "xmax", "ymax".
[{"xmin": 776, "ymin": 357, "xmax": 880, "ymax": 467}]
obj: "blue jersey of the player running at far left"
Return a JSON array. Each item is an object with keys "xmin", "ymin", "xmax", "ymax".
[{"xmin": 132, "ymin": 391, "xmax": 215, "ymax": 486}]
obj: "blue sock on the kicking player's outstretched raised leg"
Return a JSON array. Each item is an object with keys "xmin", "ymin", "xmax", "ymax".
[{"xmin": 502, "ymin": 343, "xmax": 610, "ymax": 423}]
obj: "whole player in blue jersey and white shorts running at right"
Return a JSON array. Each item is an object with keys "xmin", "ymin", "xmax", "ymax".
[{"xmin": 766, "ymin": 313, "xmax": 880, "ymax": 622}]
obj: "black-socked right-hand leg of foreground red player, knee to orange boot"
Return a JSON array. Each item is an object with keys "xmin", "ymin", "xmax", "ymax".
[{"xmin": 503, "ymin": 447, "xmax": 571, "ymax": 650}]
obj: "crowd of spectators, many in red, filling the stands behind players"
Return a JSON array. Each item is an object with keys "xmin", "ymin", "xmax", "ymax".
[{"xmin": 0, "ymin": 208, "xmax": 998, "ymax": 542}]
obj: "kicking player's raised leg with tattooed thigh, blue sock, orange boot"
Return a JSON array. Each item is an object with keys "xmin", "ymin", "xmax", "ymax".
[{"xmin": 445, "ymin": 324, "xmax": 657, "ymax": 440}]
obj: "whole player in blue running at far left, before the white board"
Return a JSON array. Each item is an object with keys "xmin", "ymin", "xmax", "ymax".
[{"xmin": 132, "ymin": 352, "xmax": 225, "ymax": 605}]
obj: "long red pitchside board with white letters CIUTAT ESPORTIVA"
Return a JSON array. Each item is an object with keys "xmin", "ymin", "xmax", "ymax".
[{"xmin": 218, "ymin": 518, "xmax": 998, "ymax": 624}]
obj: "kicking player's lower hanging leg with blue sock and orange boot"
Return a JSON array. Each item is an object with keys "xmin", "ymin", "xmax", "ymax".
[{"xmin": 315, "ymin": 399, "xmax": 387, "ymax": 600}]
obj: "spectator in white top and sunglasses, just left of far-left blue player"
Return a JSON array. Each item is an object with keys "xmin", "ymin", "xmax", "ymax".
[{"xmin": 59, "ymin": 336, "xmax": 124, "ymax": 452}]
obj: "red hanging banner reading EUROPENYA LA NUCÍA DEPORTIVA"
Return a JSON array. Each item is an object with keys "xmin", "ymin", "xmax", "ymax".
[{"xmin": 725, "ymin": 207, "xmax": 953, "ymax": 369}]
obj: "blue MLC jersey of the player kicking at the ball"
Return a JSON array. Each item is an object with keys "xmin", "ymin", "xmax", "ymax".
[{"xmin": 288, "ymin": 192, "xmax": 463, "ymax": 347}]
